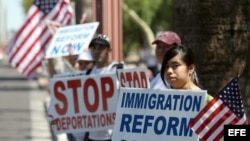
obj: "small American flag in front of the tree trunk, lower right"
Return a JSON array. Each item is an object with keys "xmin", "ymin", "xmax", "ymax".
[{"xmin": 189, "ymin": 77, "xmax": 248, "ymax": 141}]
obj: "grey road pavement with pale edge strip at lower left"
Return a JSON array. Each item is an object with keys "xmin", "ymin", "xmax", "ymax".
[{"xmin": 0, "ymin": 56, "xmax": 52, "ymax": 141}]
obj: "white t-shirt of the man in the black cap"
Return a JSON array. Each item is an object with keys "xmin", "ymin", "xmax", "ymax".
[{"xmin": 89, "ymin": 62, "xmax": 118, "ymax": 140}]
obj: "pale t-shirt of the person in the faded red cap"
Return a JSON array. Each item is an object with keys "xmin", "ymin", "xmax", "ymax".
[{"xmin": 150, "ymin": 73, "xmax": 171, "ymax": 90}]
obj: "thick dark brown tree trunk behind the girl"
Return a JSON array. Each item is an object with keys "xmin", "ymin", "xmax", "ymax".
[{"xmin": 173, "ymin": 0, "xmax": 250, "ymax": 119}]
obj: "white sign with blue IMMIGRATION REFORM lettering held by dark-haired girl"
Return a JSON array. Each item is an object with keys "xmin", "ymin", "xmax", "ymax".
[{"xmin": 112, "ymin": 88, "xmax": 207, "ymax": 141}]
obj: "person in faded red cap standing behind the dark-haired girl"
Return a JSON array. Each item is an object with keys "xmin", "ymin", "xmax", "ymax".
[{"xmin": 150, "ymin": 31, "xmax": 181, "ymax": 89}]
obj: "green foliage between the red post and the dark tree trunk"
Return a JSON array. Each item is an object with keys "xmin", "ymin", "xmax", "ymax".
[{"xmin": 123, "ymin": 0, "xmax": 173, "ymax": 56}]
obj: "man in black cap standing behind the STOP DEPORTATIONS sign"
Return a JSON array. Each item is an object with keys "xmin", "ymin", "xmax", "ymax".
[{"xmin": 88, "ymin": 34, "xmax": 122, "ymax": 141}]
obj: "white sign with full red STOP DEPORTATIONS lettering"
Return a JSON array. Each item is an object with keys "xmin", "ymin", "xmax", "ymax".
[{"xmin": 48, "ymin": 73, "xmax": 118, "ymax": 134}]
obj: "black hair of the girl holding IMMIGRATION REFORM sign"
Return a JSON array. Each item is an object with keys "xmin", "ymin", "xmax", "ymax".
[{"xmin": 161, "ymin": 45, "xmax": 199, "ymax": 85}]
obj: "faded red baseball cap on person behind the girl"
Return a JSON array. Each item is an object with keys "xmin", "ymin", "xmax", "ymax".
[{"xmin": 152, "ymin": 31, "xmax": 181, "ymax": 45}]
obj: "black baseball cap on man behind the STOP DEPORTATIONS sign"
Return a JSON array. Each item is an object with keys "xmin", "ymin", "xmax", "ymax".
[{"xmin": 90, "ymin": 34, "xmax": 110, "ymax": 47}]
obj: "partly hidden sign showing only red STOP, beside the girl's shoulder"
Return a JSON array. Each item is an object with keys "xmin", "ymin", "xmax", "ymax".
[{"xmin": 117, "ymin": 68, "xmax": 150, "ymax": 88}]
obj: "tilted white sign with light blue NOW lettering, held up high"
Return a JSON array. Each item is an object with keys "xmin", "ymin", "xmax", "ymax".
[{"xmin": 46, "ymin": 22, "xmax": 99, "ymax": 58}]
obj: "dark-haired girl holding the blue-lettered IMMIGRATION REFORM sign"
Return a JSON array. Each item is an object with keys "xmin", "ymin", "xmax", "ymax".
[{"xmin": 160, "ymin": 45, "xmax": 213, "ymax": 103}]
